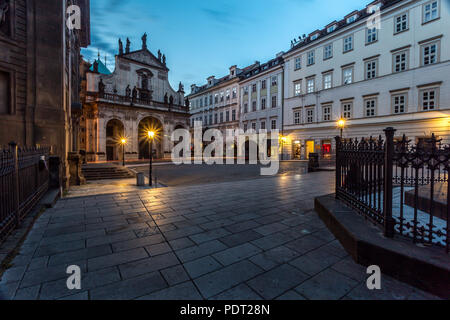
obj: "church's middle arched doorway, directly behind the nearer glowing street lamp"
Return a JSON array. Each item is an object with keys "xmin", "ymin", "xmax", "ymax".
[{"xmin": 138, "ymin": 117, "xmax": 163, "ymax": 159}]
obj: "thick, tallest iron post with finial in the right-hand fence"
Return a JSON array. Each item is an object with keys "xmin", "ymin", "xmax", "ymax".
[{"xmin": 383, "ymin": 127, "xmax": 397, "ymax": 238}]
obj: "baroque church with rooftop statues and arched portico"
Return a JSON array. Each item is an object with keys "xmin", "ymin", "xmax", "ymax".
[{"xmin": 75, "ymin": 34, "xmax": 189, "ymax": 162}]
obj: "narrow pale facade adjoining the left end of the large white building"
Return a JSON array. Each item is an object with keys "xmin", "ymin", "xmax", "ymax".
[{"xmin": 239, "ymin": 56, "xmax": 284, "ymax": 151}]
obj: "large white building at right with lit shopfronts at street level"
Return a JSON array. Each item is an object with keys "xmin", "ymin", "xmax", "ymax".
[{"xmin": 283, "ymin": 0, "xmax": 450, "ymax": 159}]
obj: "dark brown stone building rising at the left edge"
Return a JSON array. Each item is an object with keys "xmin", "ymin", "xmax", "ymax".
[{"xmin": 0, "ymin": 0, "xmax": 90, "ymax": 186}]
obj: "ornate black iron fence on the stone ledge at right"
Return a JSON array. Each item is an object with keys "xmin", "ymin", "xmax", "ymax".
[{"xmin": 336, "ymin": 128, "xmax": 450, "ymax": 252}]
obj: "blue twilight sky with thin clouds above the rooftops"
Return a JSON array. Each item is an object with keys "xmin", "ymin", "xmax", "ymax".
[{"xmin": 83, "ymin": 0, "xmax": 371, "ymax": 92}]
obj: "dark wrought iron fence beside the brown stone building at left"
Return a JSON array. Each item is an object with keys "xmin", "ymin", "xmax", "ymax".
[{"xmin": 0, "ymin": 144, "xmax": 50, "ymax": 242}]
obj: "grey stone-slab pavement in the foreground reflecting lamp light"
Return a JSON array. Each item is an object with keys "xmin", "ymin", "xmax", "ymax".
[{"xmin": 0, "ymin": 172, "xmax": 434, "ymax": 300}]
